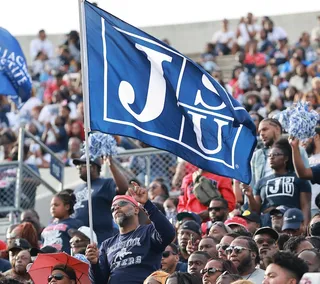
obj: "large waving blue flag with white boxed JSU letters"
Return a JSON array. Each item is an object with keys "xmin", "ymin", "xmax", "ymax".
[{"xmin": 84, "ymin": 2, "xmax": 256, "ymax": 183}]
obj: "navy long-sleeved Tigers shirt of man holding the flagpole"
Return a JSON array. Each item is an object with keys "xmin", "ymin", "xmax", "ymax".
[{"xmin": 89, "ymin": 201, "xmax": 175, "ymax": 284}]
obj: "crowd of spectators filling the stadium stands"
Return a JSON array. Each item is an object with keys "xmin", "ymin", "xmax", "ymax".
[{"xmin": 0, "ymin": 10, "xmax": 320, "ymax": 284}]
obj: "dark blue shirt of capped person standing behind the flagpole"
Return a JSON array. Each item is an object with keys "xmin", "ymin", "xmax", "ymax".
[{"xmin": 73, "ymin": 178, "xmax": 117, "ymax": 244}]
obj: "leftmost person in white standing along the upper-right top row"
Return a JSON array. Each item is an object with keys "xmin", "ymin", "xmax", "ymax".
[{"xmin": 212, "ymin": 19, "xmax": 235, "ymax": 55}]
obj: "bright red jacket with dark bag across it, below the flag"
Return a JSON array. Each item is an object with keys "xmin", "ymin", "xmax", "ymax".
[{"xmin": 178, "ymin": 171, "xmax": 236, "ymax": 221}]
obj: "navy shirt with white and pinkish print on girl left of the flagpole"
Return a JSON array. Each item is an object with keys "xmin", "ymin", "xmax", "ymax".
[{"xmin": 41, "ymin": 218, "xmax": 83, "ymax": 254}]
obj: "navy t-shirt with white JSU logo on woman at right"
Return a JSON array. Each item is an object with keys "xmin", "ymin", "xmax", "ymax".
[{"xmin": 253, "ymin": 173, "xmax": 311, "ymax": 212}]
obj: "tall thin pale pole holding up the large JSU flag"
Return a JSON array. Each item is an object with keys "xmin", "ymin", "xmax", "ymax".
[{"xmin": 78, "ymin": 0, "xmax": 93, "ymax": 242}]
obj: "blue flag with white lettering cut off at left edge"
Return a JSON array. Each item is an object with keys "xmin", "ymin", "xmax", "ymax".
[{"xmin": 0, "ymin": 27, "xmax": 32, "ymax": 106}]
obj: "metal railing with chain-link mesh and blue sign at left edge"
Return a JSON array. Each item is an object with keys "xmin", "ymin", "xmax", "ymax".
[{"xmin": 0, "ymin": 127, "xmax": 64, "ymax": 222}]
